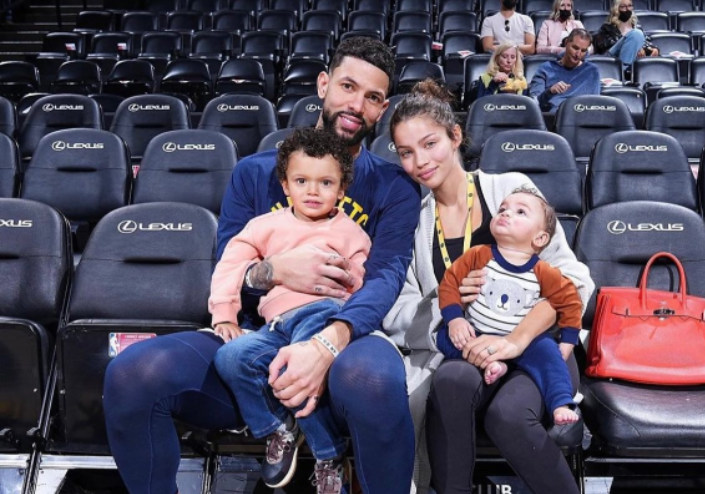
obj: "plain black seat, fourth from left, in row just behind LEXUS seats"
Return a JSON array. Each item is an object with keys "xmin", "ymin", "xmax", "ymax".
[{"xmin": 159, "ymin": 59, "xmax": 212, "ymax": 110}]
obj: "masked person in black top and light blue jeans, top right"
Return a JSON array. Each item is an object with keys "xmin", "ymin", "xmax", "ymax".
[{"xmin": 595, "ymin": 0, "xmax": 659, "ymax": 66}]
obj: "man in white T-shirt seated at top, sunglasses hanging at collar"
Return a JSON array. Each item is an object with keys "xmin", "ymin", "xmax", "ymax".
[{"xmin": 480, "ymin": 0, "xmax": 536, "ymax": 55}]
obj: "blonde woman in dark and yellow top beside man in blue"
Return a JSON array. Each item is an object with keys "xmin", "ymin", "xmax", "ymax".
[{"xmin": 477, "ymin": 43, "xmax": 528, "ymax": 98}]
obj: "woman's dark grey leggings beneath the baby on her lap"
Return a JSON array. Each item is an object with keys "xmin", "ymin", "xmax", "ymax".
[{"xmin": 426, "ymin": 357, "xmax": 579, "ymax": 494}]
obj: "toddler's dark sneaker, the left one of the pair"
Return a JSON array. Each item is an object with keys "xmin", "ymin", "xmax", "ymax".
[{"xmin": 261, "ymin": 426, "xmax": 304, "ymax": 489}]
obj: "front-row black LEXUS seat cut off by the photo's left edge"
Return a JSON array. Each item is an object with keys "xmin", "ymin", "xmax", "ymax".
[{"xmin": 0, "ymin": 199, "xmax": 71, "ymax": 454}]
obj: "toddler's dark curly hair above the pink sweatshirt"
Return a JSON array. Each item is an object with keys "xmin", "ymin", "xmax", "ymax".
[{"xmin": 277, "ymin": 127, "xmax": 353, "ymax": 189}]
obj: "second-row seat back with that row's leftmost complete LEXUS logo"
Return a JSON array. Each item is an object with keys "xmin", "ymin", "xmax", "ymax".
[{"xmin": 20, "ymin": 129, "xmax": 132, "ymax": 247}]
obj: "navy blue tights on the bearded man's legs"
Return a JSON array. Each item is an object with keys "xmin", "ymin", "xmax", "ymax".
[{"xmin": 103, "ymin": 331, "xmax": 414, "ymax": 494}]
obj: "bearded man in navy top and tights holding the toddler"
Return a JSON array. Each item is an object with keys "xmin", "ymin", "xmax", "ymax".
[{"xmin": 104, "ymin": 37, "xmax": 420, "ymax": 494}]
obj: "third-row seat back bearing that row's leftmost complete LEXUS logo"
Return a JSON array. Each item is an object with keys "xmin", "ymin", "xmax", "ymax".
[{"xmin": 17, "ymin": 94, "xmax": 103, "ymax": 158}]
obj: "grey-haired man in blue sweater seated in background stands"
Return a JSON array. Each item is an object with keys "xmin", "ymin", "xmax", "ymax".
[{"xmin": 529, "ymin": 29, "xmax": 600, "ymax": 113}]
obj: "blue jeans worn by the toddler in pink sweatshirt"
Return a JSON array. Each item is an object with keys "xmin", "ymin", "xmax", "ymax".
[{"xmin": 215, "ymin": 299, "xmax": 347, "ymax": 460}]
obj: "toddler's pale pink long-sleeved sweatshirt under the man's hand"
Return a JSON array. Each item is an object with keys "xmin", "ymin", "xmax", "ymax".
[{"xmin": 208, "ymin": 208, "xmax": 371, "ymax": 325}]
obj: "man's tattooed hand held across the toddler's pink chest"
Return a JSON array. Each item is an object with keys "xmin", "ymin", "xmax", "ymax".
[{"xmin": 260, "ymin": 245, "xmax": 355, "ymax": 298}]
